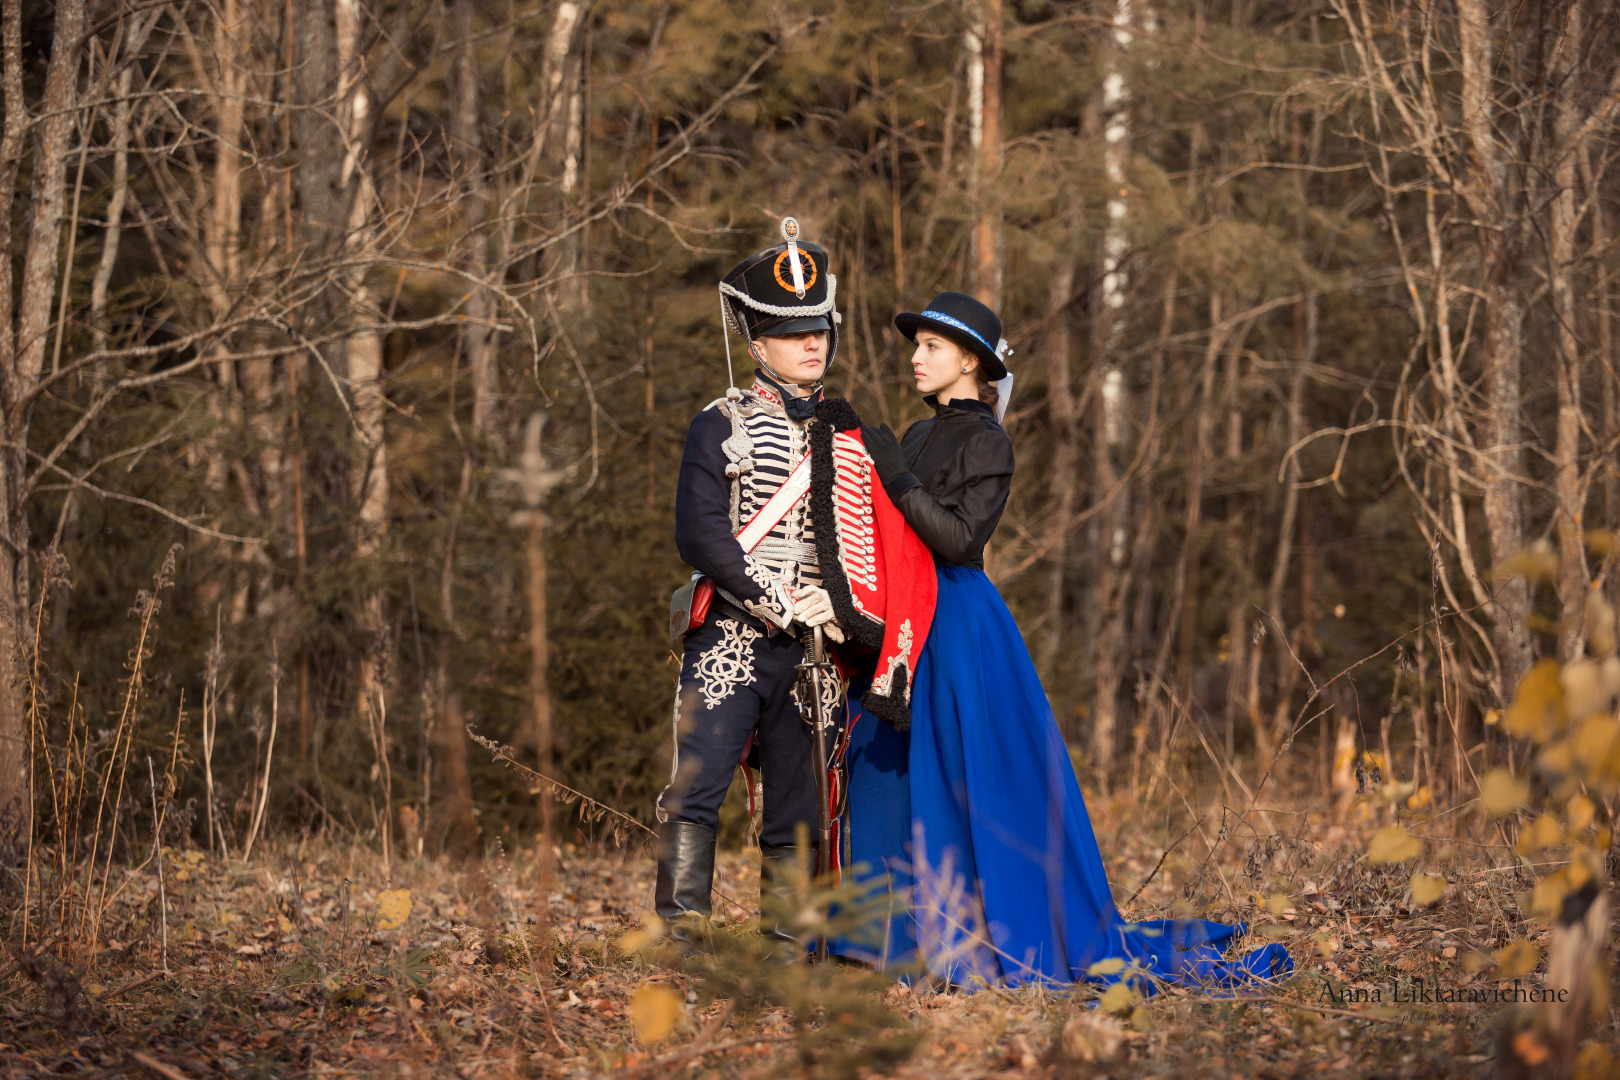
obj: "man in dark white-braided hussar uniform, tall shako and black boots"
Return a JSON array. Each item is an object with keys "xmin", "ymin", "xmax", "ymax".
[{"xmin": 654, "ymin": 219, "xmax": 842, "ymax": 936}]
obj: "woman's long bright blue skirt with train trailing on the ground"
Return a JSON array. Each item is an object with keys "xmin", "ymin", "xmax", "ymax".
[{"xmin": 829, "ymin": 567, "xmax": 1293, "ymax": 993}]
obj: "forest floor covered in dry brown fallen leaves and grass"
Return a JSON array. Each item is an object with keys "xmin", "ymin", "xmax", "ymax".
[{"xmin": 0, "ymin": 777, "xmax": 1617, "ymax": 1080}]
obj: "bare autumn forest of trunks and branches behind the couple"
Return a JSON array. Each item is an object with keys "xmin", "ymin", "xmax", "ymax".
[{"xmin": 0, "ymin": 0, "xmax": 1620, "ymax": 852}]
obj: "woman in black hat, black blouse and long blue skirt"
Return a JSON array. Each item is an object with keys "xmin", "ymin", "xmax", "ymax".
[{"xmin": 833, "ymin": 293, "xmax": 1293, "ymax": 993}]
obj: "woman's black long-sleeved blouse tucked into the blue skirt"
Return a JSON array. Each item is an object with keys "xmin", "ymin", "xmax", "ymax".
[{"xmin": 883, "ymin": 395, "xmax": 1013, "ymax": 570}]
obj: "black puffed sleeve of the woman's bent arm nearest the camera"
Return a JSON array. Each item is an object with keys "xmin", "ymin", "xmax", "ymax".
[{"xmin": 889, "ymin": 427, "xmax": 1013, "ymax": 563}]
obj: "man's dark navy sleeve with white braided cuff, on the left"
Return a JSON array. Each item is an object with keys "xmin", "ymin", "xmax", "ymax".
[{"xmin": 676, "ymin": 408, "xmax": 794, "ymax": 628}]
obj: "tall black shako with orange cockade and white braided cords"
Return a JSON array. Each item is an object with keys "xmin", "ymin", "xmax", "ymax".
[{"xmin": 719, "ymin": 217, "xmax": 839, "ymax": 368}]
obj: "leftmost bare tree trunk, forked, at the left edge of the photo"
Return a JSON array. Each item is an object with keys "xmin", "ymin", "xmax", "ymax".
[{"xmin": 0, "ymin": 0, "xmax": 84, "ymax": 810}]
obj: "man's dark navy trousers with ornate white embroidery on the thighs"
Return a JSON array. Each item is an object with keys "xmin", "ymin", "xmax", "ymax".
[{"xmin": 658, "ymin": 612, "xmax": 818, "ymax": 845}]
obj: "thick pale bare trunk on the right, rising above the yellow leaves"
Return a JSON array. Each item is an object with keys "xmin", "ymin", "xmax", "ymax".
[{"xmin": 1456, "ymin": 0, "xmax": 1531, "ymax": 696}]
